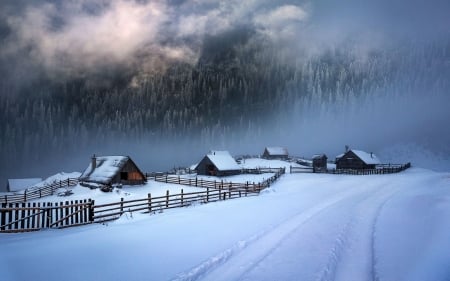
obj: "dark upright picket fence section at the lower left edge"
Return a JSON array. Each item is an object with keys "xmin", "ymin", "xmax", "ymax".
[{"xmin": 0, "ymin": 199, "xmax": 93, "ymax": 232}]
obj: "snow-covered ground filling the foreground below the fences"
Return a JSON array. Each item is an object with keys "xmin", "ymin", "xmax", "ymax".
[{"xmin": 0, "ymin": 160, "xmax": 450, "ymax": 281}]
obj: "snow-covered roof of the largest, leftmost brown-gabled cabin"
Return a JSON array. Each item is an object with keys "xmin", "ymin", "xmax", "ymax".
[{"xmin": 80, "ymin": 156, "xmax": 129, "ymax": 184}]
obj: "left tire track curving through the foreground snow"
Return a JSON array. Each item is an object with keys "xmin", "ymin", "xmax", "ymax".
[{"xmin": 172, "ymin": 186, "xmax": 370, "ymax": 281}]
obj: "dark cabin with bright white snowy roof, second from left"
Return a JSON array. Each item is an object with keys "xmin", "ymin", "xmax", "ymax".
[{"xmin": 195, "ymin": 151, "xmax": 241, "ymax": 177}]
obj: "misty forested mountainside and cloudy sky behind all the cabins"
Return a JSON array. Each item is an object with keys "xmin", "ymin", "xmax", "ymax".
[{"xmin": 0, "ymin": 0, "xmax": 450, "ymax": 182}]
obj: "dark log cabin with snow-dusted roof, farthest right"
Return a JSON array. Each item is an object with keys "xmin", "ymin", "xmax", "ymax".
[{"xmin": 336, "ymin": 149, "xmax": 381, "ymax": 170}]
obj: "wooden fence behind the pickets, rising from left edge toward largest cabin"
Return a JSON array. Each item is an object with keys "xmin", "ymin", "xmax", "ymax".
[{"xmin": 0, "ymin": 178, "xmax": 78, "ymax": 204}]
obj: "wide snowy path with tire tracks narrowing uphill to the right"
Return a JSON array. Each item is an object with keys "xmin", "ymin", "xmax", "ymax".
[{"xmin": 173, "ymin": 175, "xmax": 416, "ymax": 281}]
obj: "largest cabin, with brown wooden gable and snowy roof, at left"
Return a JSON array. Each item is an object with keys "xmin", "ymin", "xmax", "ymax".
[{"xmin": 79, "ymin": 155, "xmax": 147, "ymax": 186}]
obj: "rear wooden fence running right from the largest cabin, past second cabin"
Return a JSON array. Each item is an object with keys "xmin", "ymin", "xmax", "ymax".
[{"xmin": 148, "ymin": 168, "xmax": 285, "ymax": 190}]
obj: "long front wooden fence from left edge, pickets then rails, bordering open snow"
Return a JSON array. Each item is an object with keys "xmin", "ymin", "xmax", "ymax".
[{"xmin": 0, "ymin": 169, "xmax": 285, "ymax": 233}]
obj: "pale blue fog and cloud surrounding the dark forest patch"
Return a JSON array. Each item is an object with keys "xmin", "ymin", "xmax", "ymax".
[{"xmin": 0, "ymin": 0, "xmax": 450, "ymax": 186}]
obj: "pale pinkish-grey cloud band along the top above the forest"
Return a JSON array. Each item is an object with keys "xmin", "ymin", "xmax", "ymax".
[{"xmin": 0, "ymin": 0, "xmax": 450, "ymax": 83}]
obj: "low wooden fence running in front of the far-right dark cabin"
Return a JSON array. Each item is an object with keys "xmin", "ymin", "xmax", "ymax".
[{"xmin": 290, "ymin": 163, "xmax": 411, "ymax": 175}]
